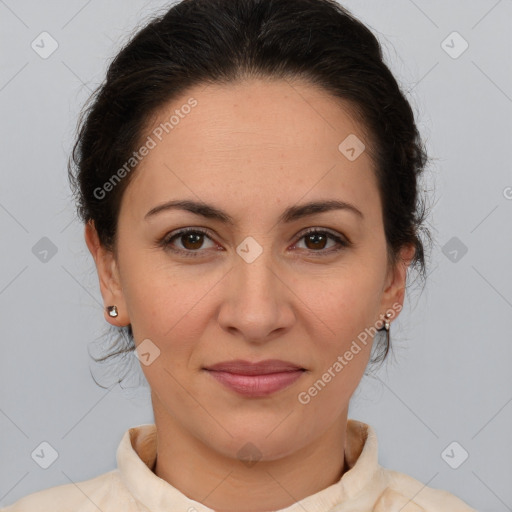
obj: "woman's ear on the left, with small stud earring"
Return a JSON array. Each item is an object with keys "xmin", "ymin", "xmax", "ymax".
[{"xmin": 85, "ymin": 220, "xmax": 130, "ymax": 327}]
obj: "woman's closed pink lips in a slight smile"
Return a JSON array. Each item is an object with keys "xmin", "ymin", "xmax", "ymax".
[{"xmin": 205, "ymin": 359, "xmax": 305, "ymax": 397}]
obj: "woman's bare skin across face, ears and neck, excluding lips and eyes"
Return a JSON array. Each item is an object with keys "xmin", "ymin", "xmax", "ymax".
[{"xmin": 85, "ymin": 79, "xmax": 414, "ymax": 512}]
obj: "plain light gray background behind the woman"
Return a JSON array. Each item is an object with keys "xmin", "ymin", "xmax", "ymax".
[{"xmin": 0, "ymin": 0, "xmax": 512, "ymax": 512}]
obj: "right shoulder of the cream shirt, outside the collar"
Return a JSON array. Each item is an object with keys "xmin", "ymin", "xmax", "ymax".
[{"xmin": 372, "ymin": 468, "xmax": 477, "ymax": 512}]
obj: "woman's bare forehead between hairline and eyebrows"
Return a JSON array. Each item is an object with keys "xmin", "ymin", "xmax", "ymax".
[{"xmin": 123, "ymin": 79, "xmax": 378, "ymax": 222}]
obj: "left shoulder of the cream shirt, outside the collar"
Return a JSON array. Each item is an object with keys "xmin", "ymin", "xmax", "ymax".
[{"xmin": 0, "ymin": 470, "xmax": 136, "ymax": 512}]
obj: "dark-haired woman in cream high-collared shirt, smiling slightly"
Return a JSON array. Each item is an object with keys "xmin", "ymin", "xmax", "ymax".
[{"xmin": 5, "ymin": 0, "xmax": 474, "ymax": 512}]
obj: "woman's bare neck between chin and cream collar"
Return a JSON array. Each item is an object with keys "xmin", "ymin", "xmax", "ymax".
[{"xmin": 153, "ymin": 403, "xmax": 349, "ymax": 512}]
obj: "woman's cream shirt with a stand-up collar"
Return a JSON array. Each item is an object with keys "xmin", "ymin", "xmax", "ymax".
[{"xmin": 2, "ymin": 419, "xmax": 476, "ymax": 512}]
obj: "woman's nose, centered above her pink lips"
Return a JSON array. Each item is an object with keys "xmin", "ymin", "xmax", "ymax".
[{"xmin": 218, "ymin": 251, "xmax": 295, "ymax": 344}]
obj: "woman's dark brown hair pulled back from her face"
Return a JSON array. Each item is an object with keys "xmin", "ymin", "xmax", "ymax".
[{"xmin": 68, "ymin": 0, "xmax": 430, "ymax": 382}]
